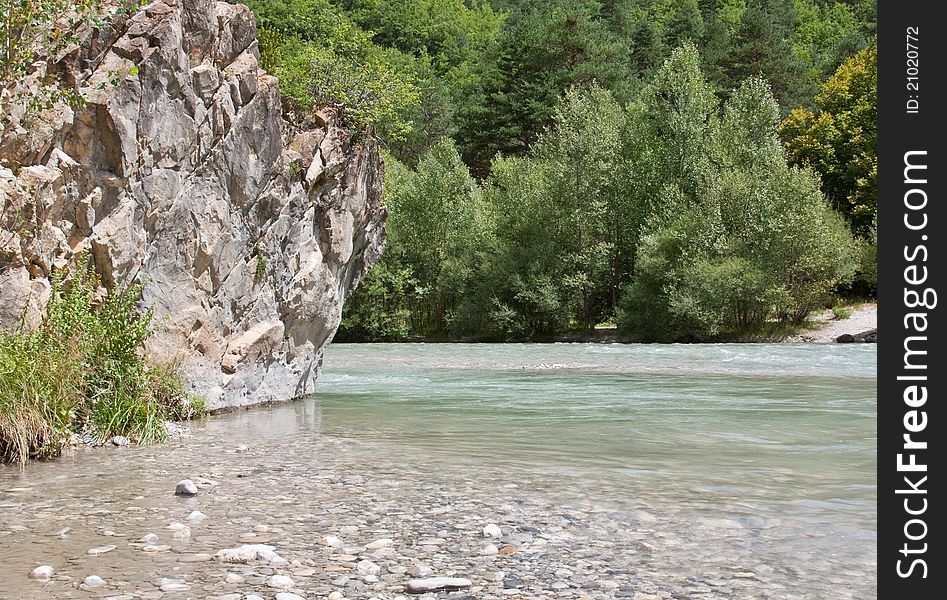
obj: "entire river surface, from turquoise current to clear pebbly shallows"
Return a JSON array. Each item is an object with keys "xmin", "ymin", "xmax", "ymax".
[{"xmin": 0, "ymin": 344, "xmax": 876, "ymax": 600}]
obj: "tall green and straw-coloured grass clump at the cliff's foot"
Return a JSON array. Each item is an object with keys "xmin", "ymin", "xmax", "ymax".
[{"xmin": 0, "ymin": 268, "xmax": 203, "ymax": 464}]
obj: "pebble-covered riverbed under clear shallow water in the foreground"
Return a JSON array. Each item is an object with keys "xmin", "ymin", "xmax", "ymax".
[{"xmin": 0, "ymin": 347, "xmax": 876, "ymax": 600}]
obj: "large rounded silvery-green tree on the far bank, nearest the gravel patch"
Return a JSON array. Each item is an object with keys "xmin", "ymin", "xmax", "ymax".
[{"xmin": 619, "ymin": 64, "xmax": 855, "ymax": 340}]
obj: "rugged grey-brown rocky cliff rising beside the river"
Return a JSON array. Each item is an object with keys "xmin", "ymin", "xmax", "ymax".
[{"xmin": 0, "ymin": 0, "xmax": 385, "ymax": 408}]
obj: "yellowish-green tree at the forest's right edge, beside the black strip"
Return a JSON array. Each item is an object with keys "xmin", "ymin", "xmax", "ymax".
[{"xmin": 780, "ymin": 45, "xmax": 878, "ymax": 238}]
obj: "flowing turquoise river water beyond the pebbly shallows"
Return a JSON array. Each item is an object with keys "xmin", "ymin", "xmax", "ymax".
[{"xmin": 315, "ymin": 344, "xmax": 876, "ymax": 598}]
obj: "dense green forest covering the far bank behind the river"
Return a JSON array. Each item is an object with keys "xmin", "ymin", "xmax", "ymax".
[{"xmin": 241, "ymin": 0, "xmax": 877, "ymax": 340}]
